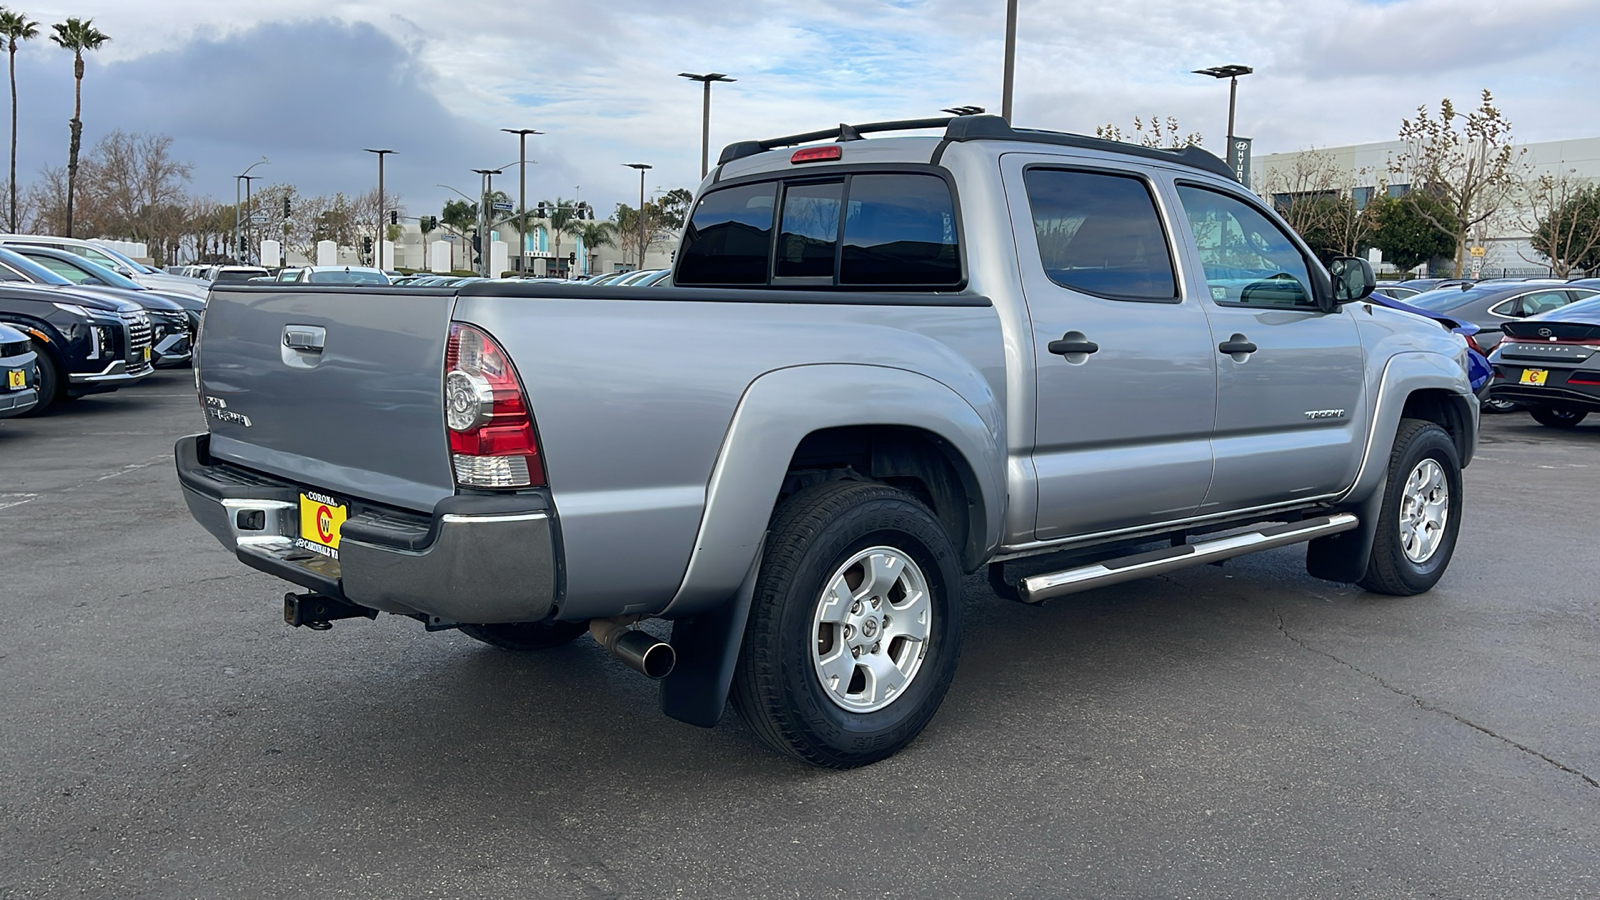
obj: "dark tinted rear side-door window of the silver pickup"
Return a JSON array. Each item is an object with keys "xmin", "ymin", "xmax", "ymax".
[{"xmin": 1024, "ymin": 168, "xmax": 1178, "ymax": 299}]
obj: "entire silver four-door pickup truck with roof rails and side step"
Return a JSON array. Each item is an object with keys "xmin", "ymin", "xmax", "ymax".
[{"xmin": 176, "ymin": 115, "xmax": 1478, "ymax": 767}]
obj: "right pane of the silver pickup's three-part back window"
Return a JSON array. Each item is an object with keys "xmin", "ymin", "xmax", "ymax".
[{"xmin": 838, "ymin": 175, "xmax": 962, "ymax": 285}]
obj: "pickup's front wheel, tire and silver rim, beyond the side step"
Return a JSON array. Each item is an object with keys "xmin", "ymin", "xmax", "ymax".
[{"xmin": 1357, "ymin": 420, "xmax": 1461, "ymax": 597}]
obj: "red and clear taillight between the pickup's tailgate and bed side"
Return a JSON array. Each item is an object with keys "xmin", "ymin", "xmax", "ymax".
[{"xmin": 445, "ymin": 322, "xmax": 544, "ymax": 488}]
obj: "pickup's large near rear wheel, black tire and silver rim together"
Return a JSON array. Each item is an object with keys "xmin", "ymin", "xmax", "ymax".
[{"xmin": 733, "ymin": 482, "xmax": 962, "ymax": 769}]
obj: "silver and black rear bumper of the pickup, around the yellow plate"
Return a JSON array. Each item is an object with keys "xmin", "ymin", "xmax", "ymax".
[{"xmin": 174, "ymin": 434, "xmax": 560, "ymax": 625}]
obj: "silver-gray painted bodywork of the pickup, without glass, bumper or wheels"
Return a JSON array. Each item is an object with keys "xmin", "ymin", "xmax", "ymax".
[{"xmin": 184, "ymin": 131, "xmax": 1477, "ymax": 620}]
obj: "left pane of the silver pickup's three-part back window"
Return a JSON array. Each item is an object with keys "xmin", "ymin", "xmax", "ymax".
[{"xmin": 677, "ymin": 183, "xmax": 778, "ymax": 285}]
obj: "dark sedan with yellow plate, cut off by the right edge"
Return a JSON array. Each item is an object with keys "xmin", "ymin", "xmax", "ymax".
[{"xmin": 1490, "ymin": 296, "xmax": 1600, "ymax": 428}]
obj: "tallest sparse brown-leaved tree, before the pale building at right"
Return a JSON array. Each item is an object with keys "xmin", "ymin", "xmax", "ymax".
[{"xmin": 1389, "ymin": 90, "xmax": 1522, "ymax": 277}]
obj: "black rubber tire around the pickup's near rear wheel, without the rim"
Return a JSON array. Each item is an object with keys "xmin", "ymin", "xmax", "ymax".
[{"xmin": 733, "ymin": 482, "xmax": 962, "ymax": 769}]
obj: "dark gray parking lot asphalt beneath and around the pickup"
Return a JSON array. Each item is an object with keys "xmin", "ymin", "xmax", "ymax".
[{"xmin": 0, "ymin": 372, "xmax": 1600, "ymax": 900}]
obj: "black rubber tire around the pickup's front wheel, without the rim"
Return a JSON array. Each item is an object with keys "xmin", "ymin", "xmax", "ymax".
[{"xmin": 1357, "ymin": 420, "xmax": 1462, "ymax": 597}]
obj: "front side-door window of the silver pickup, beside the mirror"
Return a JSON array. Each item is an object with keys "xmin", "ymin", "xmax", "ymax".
[{"xmin": 1178, "ymin": 186, "xmax": 1317, "ymax": 309}]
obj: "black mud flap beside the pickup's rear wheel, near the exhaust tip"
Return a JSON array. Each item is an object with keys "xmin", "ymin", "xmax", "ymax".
[{"xmin": 661, "ymin": 541, "xmax": 766, "ymax": 729}]
